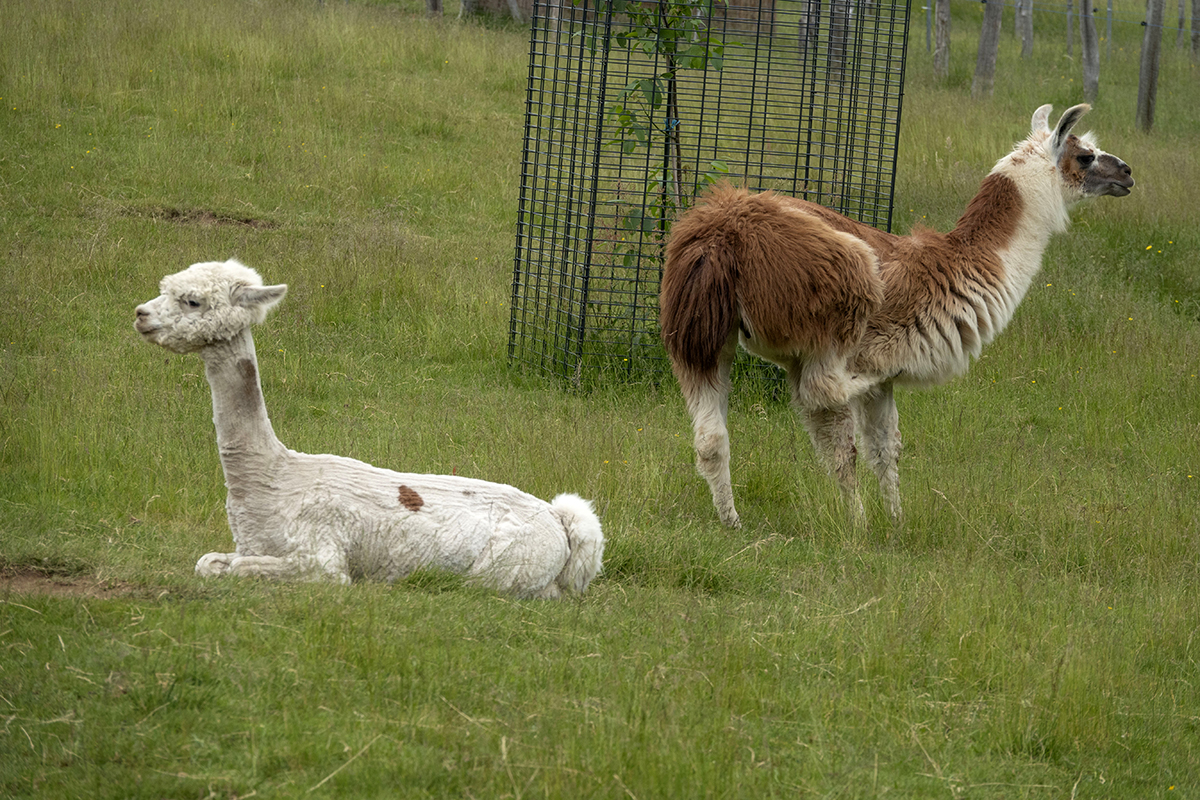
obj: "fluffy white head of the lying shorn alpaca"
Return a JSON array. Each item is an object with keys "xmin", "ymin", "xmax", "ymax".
[{"xmin": 133, "ymin": 259, "xmax": 288, "ymax": 353}]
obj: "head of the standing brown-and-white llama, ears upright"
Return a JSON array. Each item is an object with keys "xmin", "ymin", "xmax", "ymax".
[{"xmin": 1030, "ymin": 103, "xmax": 1134, "ymax": 204}]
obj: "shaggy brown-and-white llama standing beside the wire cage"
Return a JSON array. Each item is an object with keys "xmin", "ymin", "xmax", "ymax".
[{"xmin": 660, "ymin": 104, "xmax": 1134, "ymax": 528}]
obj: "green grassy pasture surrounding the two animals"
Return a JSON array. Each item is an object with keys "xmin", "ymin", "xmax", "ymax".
[{"xmin": 0, "ymin": 0, "xmax": 1200, "ymax": 800}]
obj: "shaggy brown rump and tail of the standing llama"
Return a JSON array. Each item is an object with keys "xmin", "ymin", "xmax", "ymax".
[{"xmin": 660, "ymin": 185, "xmax": 883, "ymax": 371}]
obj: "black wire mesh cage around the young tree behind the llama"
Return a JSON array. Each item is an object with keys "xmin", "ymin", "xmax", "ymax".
[{"xmin": 509, "ymin": 0, "xmax": 908, "ymax": 385}]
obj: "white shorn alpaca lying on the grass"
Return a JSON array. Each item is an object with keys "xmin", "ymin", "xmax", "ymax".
[{"xmin": 134, "ymin": 260, "xmax": 604, "ymax": 599}]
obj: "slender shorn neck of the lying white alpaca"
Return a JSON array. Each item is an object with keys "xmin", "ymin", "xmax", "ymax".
[{"xmin": 200, "ymin": 329, "xmax": 284, "ymax": 465}]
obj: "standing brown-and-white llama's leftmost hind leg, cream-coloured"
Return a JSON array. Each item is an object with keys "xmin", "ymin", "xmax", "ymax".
[{"xmin": 679, "ymin": 333, "xmax": 742, "ymax": 528}]
